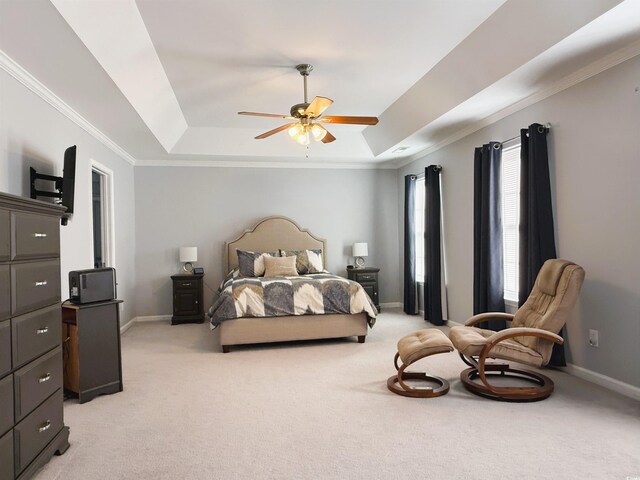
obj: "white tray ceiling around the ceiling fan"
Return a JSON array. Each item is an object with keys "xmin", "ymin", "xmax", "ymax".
[{"xmin": 0, "ymin": 0, "xmax": 640, "ymax": 167}]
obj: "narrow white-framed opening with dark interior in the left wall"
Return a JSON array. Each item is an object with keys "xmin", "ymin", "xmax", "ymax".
[{"xmin": 91, "ymin": 161, "xmax": 115, "ymax": 268}]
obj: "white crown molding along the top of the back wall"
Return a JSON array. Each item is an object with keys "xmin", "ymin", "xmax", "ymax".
[{"xmin": 136, "ymin": 160, "xmax": 397, "ymax": 170}]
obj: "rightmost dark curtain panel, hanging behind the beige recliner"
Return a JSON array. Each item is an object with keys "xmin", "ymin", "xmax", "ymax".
[{"xmin": 518, "ymin": 123, "xmax": 566, "ymax": 366}]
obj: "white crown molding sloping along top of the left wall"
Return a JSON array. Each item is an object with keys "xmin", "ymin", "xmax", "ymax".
[{"xmin": 0, "ymin": 50, "xmax": 136, "ymax": 165}]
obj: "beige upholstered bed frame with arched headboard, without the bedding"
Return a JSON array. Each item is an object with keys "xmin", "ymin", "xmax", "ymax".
[{"xmin": 209, "ymin": 216, "xmax": 377, "ymax": 353}]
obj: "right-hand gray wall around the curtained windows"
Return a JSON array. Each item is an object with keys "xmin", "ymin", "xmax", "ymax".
[{"xmin": 397, "ymin": 57, "xmax": 640, "ymax": 386}]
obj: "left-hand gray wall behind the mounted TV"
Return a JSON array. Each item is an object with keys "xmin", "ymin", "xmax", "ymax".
[{"xmin": 0, "ymin": 70, "xmax": 135, "ymax": 324}]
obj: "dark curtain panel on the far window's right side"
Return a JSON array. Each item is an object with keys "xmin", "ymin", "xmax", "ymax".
[{"xmin": 424, "ymin": 165, "xmax": 444, "ymax": 325}]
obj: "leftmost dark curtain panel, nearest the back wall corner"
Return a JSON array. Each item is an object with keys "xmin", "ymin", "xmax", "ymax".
[{"xmin": 404, "ymin": 175, "xmax": 418, "ymax": 315}]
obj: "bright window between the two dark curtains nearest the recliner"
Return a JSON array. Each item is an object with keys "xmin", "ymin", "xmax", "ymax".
[{"xmin": 502, "ymin": 142, "xmax": 520, "ymax": 302}]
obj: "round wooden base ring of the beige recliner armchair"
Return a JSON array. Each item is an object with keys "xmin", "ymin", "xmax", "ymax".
[{"xmin": 460, "ymin": 365, "xmax": 553, "ymax": 402}]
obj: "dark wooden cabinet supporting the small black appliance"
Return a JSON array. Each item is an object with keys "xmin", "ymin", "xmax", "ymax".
[{"xmin": 62, "ymin": 300, "xmax": 123, "ymax": 403}]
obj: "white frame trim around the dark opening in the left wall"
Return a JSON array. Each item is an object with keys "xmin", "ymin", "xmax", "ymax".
[{"xmin": 89, "ymin": 159, "xmax": 116, "ymax": 268}]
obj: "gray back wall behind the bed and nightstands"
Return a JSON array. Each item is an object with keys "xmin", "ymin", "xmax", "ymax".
[{"xmin": 135, "ymin": 167, "xmax": 401, "ymax": 315}]
